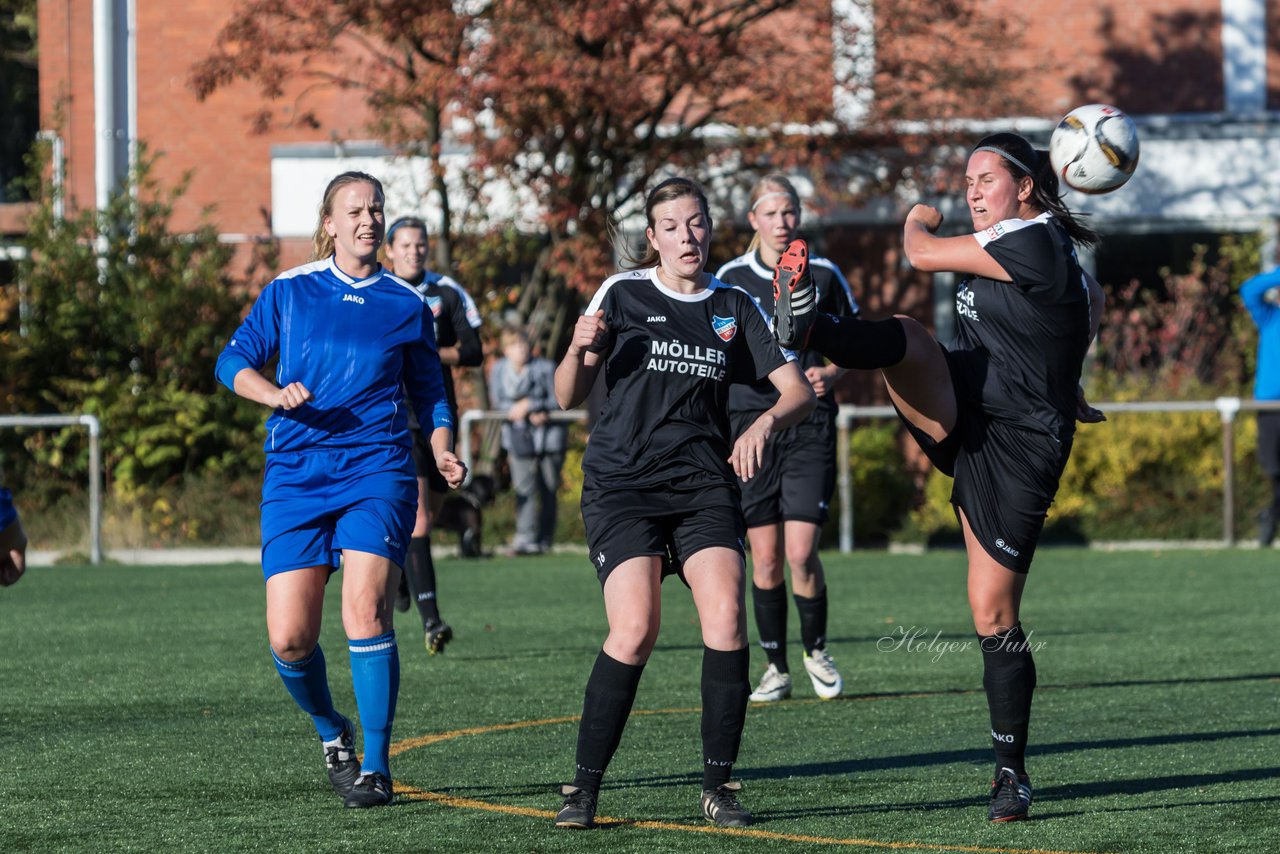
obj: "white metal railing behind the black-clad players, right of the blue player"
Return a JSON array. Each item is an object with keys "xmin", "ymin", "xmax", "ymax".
[{"xmin": 458, "ymin": 397, "xmax": 1280, "ymax": 552}]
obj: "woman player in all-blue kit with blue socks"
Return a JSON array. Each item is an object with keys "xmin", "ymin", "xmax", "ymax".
[{"xmin": 216, "ymin": 172, "xmax": 466, "ymax": 807}]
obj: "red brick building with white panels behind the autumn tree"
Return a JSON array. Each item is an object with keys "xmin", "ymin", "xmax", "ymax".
[{"xmin": 0, "ymin": 0, "xmax": 1280, "ymax": 316}]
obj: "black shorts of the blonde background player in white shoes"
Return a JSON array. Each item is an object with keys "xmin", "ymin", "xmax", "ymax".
[{"xmin": 732, "ymin": 412, "xmax": 836, "ymax": 528}]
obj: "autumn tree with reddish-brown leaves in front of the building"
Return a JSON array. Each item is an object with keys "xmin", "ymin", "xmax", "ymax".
[{"xmin": 193, "ymin": 0, "xmax": 1039, "ymax": 351}]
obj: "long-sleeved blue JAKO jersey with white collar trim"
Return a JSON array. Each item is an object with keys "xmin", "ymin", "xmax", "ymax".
[{"xmin": 209, "ymin": 257, "xmax": 453, "ymax": 453}]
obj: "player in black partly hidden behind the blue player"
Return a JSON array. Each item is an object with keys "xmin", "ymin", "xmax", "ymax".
[{"xmin": 387, "ymin": 216, "xmax": 484, "ymax": 656}]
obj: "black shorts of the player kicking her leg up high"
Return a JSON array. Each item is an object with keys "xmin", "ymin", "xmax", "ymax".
[{"xmin": 902, "ymin": 407, "xmax": 1071, "ymax": 572}]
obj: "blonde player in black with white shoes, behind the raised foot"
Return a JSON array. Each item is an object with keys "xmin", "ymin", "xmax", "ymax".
[{"xmin": 716, "ymin": 174, "xmax": 858, "ymax": 703}]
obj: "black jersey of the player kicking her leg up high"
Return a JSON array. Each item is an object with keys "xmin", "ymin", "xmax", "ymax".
[{"xmin": 950, "ymin": 214, "xmax": 1089, "ymax": 438}]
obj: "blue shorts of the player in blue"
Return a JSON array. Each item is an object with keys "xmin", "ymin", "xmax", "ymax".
[{"xmin": 262, "ymin": 446, "xmax": 417, "ymax": 577}]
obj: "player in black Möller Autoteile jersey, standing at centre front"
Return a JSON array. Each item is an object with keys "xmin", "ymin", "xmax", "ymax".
[{"xmin": 556, "ymin": 178, "xmax": 814, "ymax": 828}]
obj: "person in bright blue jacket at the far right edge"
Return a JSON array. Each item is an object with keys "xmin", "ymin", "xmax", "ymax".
[{"xmin": 1240, "ymin": 268, "xmax": 1280, "ymax": 545}]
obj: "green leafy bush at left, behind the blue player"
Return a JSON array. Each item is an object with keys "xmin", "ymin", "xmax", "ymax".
[{"xmin": 0, "ymin": 151, "xmax": 261, "ymax": 504}]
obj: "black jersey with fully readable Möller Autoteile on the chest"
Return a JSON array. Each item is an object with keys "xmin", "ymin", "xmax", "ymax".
[{"xmin": 582, "ymin": 268, "xmax": 788, "ymax": 490}]
